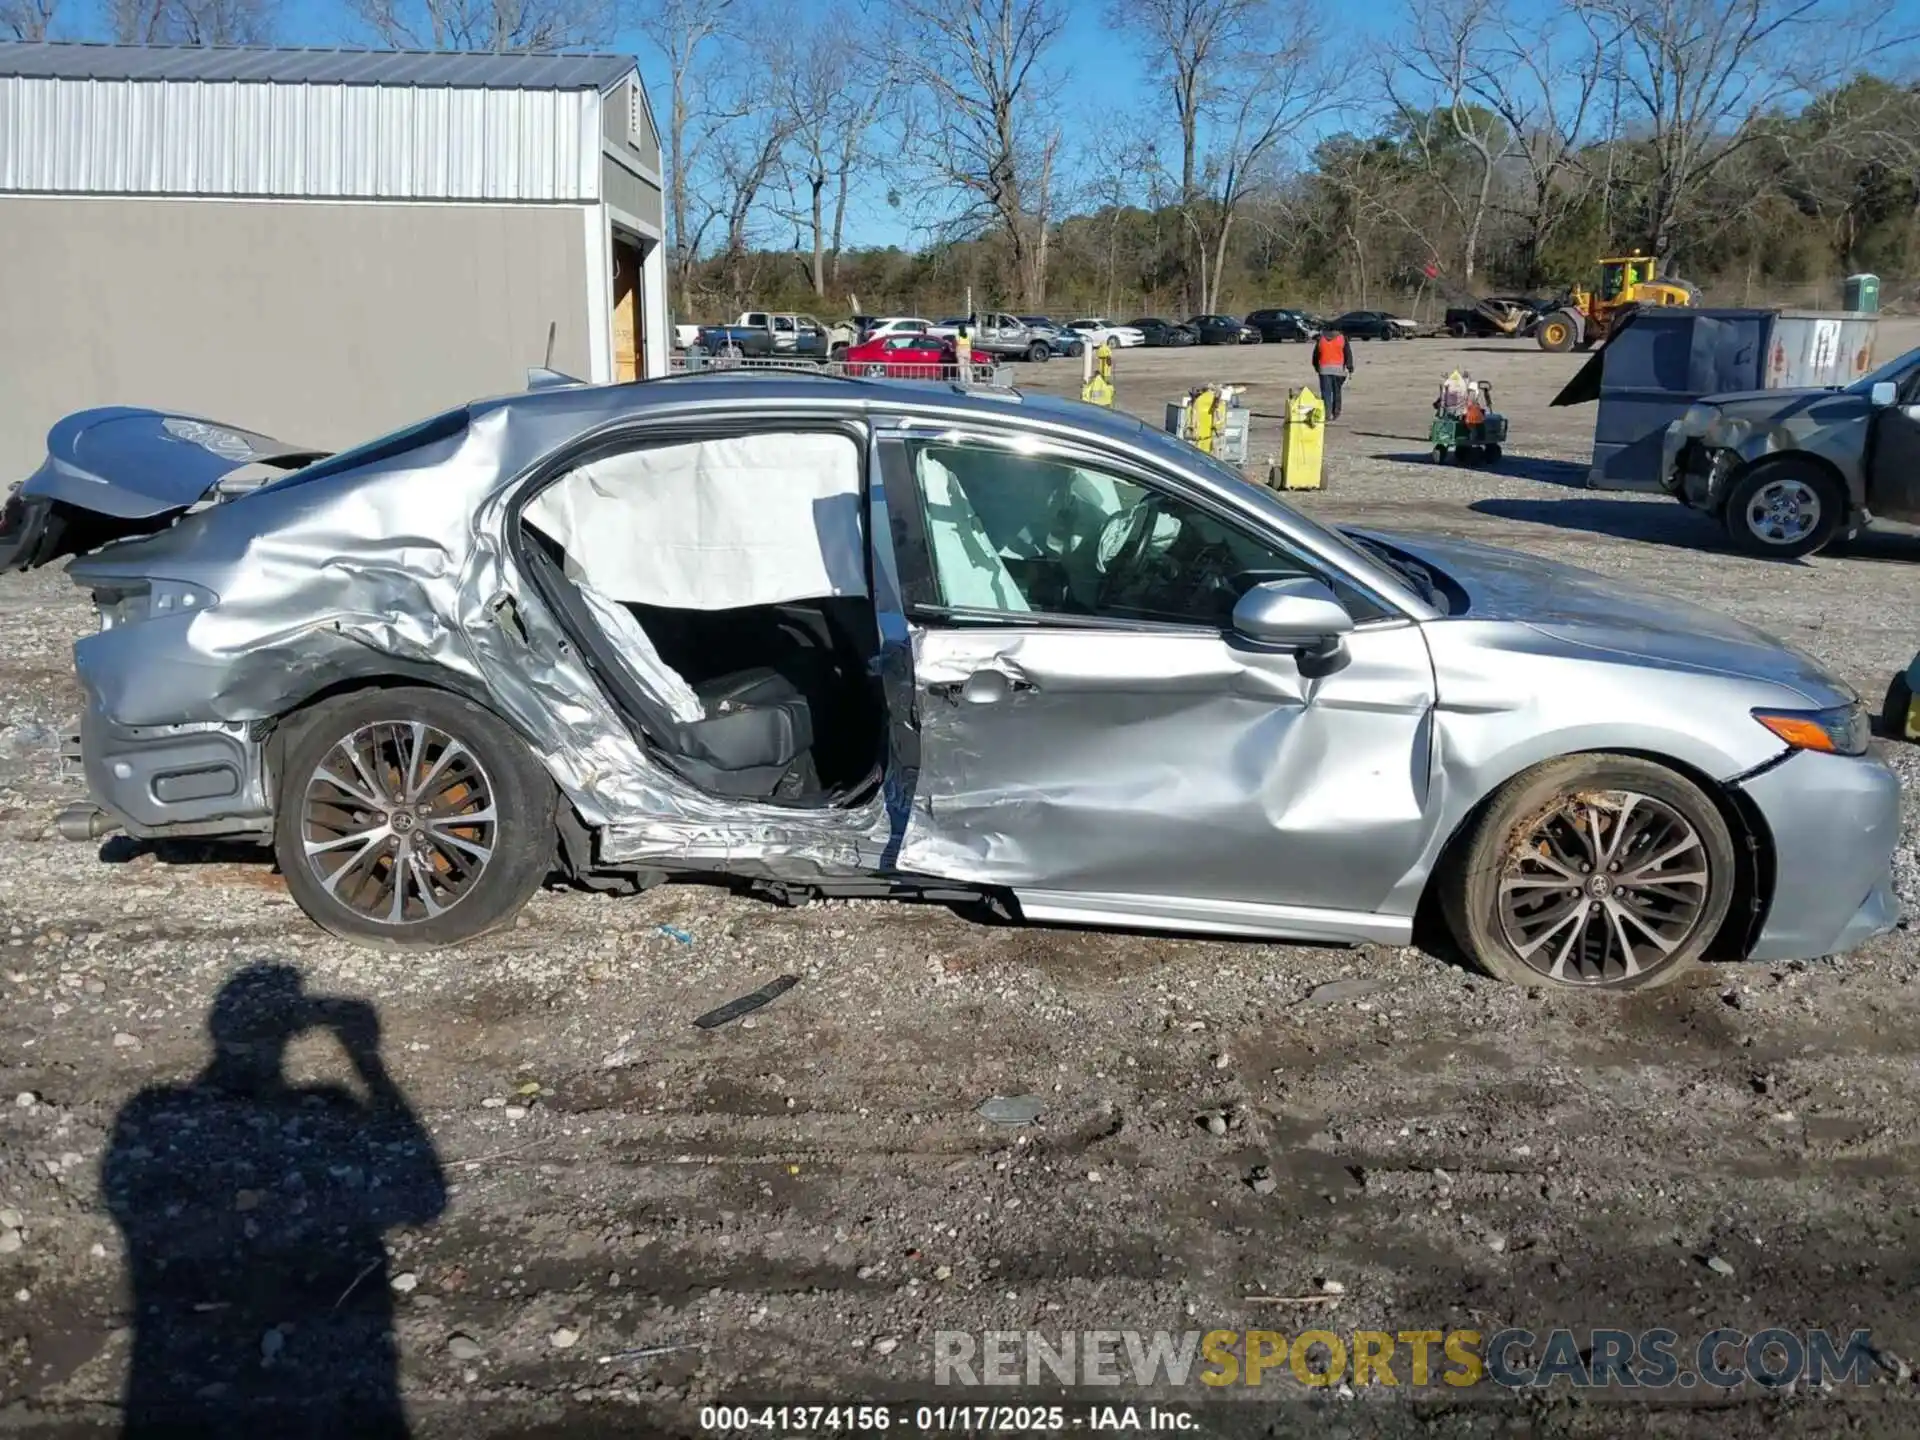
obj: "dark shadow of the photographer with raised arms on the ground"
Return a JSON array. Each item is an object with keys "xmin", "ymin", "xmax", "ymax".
[{"xmin": 102, "ymin": 966, "xmax": 447, "ymax": 1440}]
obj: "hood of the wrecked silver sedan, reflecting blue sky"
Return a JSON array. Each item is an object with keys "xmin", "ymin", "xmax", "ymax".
[{"xmin": 1356, "ymin": 530, "xmax": 1859, "ymax": 708}]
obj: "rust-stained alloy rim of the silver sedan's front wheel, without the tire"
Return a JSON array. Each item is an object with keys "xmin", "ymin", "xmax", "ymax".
[{"xmin": 1500, "ymin": 791, "xmax": 1713, "ymax": 985}]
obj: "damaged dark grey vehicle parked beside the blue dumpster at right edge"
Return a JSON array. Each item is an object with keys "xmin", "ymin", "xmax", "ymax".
[{"xmin": 1661, "ymin": 349, "xmax": 1920, "ymax": 561}]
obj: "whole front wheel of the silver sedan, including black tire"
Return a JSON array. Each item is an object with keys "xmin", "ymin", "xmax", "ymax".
[{"xmin": 1440, "ymin": 755, "xmax": 1738, "ymax": 991}]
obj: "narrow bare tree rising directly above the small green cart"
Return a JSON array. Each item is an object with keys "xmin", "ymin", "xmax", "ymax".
[{"xmin": 1380, "ymin": 0, "xmax": 1513, "ymax": 286}]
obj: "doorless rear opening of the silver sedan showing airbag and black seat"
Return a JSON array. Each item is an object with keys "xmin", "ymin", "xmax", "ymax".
[{"xmin": 520, "ymin": 432, "xmax": 885, "ymax": 806}]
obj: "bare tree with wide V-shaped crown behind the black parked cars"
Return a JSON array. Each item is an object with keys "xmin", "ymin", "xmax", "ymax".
[{"xmin": 1114, "ymin": 0, "xmax": 1334, "ymax": 311}]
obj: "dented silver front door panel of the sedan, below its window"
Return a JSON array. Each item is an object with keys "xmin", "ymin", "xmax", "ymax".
[{"xmin": 904, "ymin": 624, "xmax": 1434, "ymax": 929}]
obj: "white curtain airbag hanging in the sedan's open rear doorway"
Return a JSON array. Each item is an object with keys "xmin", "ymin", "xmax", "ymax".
[{"xmin": 526, "ymin": 434, "xmax": 866, "ymax": 611}]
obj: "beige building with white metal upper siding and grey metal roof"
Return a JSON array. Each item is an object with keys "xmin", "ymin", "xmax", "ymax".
[{"xmin": 0, "ymin": 42, "xmax": 668, "ymax": 480}]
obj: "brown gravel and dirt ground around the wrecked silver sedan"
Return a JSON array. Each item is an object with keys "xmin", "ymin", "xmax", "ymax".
[{"xmin": 0, "ymin": 323, "xmax": 1920, "ymax": 1438}]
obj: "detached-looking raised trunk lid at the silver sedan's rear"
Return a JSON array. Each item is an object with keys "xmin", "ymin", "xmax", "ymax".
[{"xmin": 0, "ymin": 405, "xmax": 328, "ymax": 570}]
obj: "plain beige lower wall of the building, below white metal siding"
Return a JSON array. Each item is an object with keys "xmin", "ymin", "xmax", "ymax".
[{"xmin": 0, "ymin": 196, "xmax": 599, "ymax": 480}]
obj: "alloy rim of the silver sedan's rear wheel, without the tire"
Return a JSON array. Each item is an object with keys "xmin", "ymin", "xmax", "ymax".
[{"xmin": 301, "ymin": 720, "xmax": 497, "ymax": 925}]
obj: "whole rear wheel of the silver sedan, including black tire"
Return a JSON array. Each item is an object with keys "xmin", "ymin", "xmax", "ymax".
[{"xmin": 273, "ymin": 685, "xmax": 559, "ymax": 948}]
